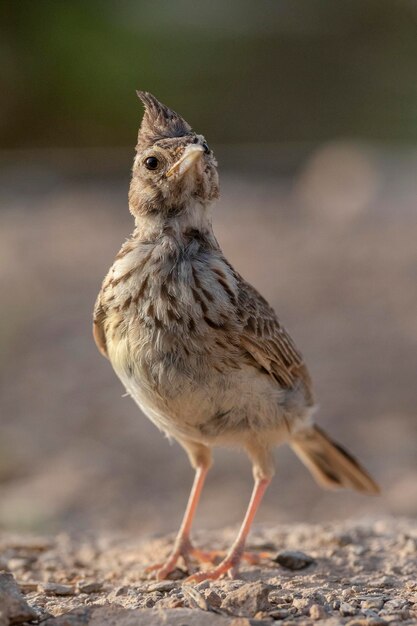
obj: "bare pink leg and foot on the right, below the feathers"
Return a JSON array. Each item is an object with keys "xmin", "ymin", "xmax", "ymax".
[{"xmin": 187, "ymin": 478, "xmax": 271, "ymax": 582}]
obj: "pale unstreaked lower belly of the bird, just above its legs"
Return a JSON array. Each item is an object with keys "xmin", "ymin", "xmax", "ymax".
[{"xmin": 110, "ymin": 332, "xmax": 306, "ymax": 445}]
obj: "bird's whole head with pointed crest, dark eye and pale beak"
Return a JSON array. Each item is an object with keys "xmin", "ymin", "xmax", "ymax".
[{"xmin": 129, "ymin": 91, "xmax": 219, "ymax": 217}]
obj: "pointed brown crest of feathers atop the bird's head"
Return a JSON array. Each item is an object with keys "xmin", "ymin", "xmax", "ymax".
[{"xmin": 136, "ymin": 91, "xmax": 191, "ymax": 147}]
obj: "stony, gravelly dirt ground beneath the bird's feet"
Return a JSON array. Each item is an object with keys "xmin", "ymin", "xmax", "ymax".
[{"xmin": 0, "ymin": 518, "xmax": 417, "ymax": 626}]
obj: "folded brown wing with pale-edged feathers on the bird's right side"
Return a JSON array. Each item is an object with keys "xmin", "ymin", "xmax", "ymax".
[{"xmin": 234, "ymin": 276, "xmax": 311, "ymax": 395}]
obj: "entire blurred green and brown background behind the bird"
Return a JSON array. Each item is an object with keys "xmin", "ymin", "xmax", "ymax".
[{"xmin": 0, "ymin": 0, "xmax": 417, "ymax": 533}]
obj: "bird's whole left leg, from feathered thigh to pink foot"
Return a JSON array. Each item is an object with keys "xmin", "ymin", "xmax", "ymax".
[{"xmin": 147, "ymin": 442, "xmax": 211, "ymax": 580}]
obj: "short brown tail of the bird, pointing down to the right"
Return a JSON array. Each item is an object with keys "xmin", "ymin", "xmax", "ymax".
[{"xmin": 289, "ymin": 425, "xmax": 379, "ymax": 494}]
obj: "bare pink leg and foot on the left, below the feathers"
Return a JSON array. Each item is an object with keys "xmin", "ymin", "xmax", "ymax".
[{"xmin": 147, "ymin": 464, "xmax": 209, "ymax": 580}]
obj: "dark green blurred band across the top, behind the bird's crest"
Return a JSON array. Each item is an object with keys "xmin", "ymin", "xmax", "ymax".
[{"xmin": 0, "ymin": 0, "xmax": 417, "ymax": 147}]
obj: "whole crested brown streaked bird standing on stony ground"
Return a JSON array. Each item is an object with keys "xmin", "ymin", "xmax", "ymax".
[{"xmin": 93, "ymin": 91, "xmax": 379, "ymax": 583}]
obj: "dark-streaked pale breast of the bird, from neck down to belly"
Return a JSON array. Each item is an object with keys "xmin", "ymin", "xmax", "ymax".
[{"xmin": 103, "ymin": 236, "xmax": 239, "ymax": 436}]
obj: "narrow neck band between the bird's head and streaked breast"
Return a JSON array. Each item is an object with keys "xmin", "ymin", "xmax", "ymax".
[{"xmin": 134, "ymin": 203, "xmax": 218, "ymax": 248}]
